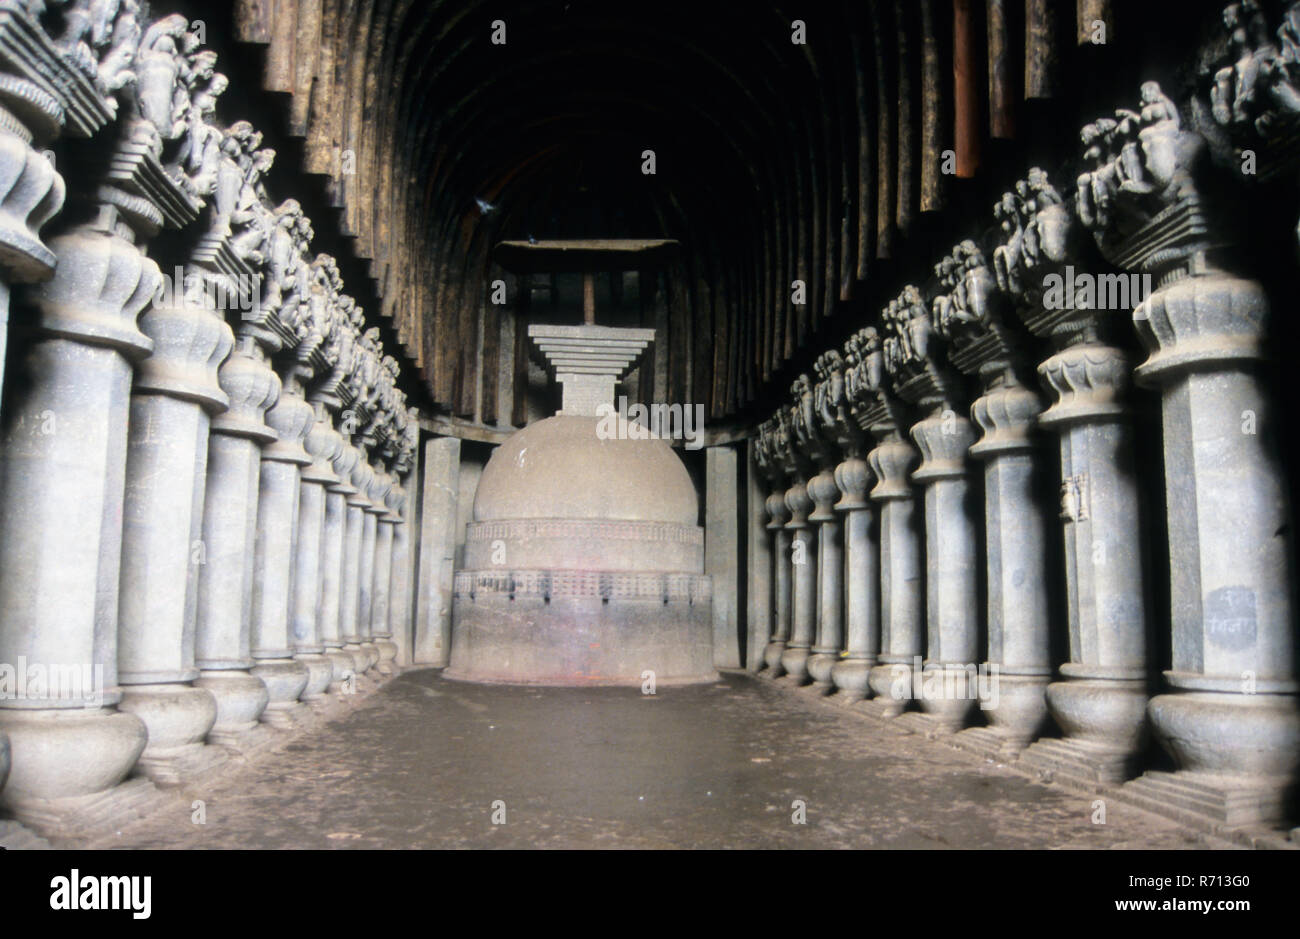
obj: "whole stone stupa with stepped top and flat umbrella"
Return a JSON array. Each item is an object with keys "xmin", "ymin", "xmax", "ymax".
[{"xmin": 445, "ymin": 242, "xmax": 718, "ymax": 685}]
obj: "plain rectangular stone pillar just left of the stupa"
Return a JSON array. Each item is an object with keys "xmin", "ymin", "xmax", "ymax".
[{"xmin": 415, "ymin": 437, "xmax": 460, "ymax": 667}]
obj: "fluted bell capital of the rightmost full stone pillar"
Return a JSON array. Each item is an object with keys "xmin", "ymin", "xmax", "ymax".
[{"xmin": 1134, "ymin": 274, "xmax": 1269, "ymax": 385}]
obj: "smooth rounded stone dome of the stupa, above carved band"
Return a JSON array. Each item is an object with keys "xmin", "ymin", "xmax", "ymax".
[{"xmin": 475, "ymin": 414, "xmax": 699, "ymax": 527}]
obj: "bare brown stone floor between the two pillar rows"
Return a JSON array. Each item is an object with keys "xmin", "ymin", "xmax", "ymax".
[{"xmin": 88, "ymin": 670, "xmax": 1205, "ymax": 848}]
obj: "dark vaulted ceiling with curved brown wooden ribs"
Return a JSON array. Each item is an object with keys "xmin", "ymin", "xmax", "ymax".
[{"xmin": 223, "ymin": 0, "xmax": 1206, "ymax": 423}]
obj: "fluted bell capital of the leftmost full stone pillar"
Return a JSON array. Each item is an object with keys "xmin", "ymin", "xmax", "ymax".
[{"xmin": 27, "ymin": 226, "xmax": 163, "ymax": 356}]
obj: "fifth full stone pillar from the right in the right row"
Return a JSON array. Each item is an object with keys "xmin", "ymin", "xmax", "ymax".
[{"xmin": 867, "ymin": 432, "xmax": 924, "ymax": 717}]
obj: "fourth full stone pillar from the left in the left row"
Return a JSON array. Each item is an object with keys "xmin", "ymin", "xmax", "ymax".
[{"xmin": 252, "ymin": 363, "xmax": 317, "ymax": 727}]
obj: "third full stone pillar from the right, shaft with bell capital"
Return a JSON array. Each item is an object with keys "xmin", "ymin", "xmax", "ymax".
[{"xmin": 971, "ymin": 384, "xmax": 1052, "ymax": 756}]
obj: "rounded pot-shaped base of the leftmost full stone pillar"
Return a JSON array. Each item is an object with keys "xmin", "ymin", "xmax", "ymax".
[{"xmin": 0, "ymin": 708, "xmax": 152, "ymax": 806}]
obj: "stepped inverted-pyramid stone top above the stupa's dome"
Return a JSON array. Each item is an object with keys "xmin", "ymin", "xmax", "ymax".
[{"xmin": 528, "ymin": 324, "xmax": 654, "ymax": 417}]
